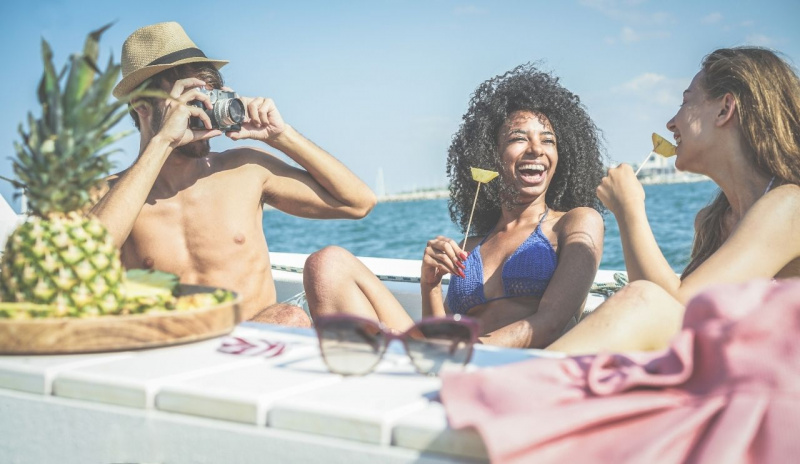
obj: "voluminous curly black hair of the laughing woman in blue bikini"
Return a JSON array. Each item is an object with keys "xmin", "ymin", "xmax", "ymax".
[{"xmin": 447, "ymin": 63, "xmax": 603, "ymax": 235}]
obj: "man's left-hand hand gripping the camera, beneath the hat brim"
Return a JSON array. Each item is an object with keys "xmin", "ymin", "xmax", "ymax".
[{"xmin": 153, "ymin": 77, "xmax": 222, "ymax": 148}]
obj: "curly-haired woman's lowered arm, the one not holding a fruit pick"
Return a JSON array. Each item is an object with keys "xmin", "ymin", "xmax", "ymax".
[{"xmin": 481, "ymin": 208, "xmax": 604, "ymax": 348}]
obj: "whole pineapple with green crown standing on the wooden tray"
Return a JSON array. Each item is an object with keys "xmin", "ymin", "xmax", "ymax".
[{"xmin": 0, "ymin": 24, "xmax": 130, "ymax": 317}]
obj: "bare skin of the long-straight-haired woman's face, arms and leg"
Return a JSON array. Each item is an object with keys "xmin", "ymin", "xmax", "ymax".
[{"xmin": 548, "ymin": 71, "xmax": 800, "ymax": 354}]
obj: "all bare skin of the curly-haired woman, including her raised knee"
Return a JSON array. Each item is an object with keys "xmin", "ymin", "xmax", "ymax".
[{"xmin": 303, "ymin": 111, "xmax": 603, "ymax": 348}]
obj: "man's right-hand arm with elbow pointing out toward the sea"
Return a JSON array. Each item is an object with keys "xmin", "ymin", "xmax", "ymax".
[{"xmin": 228, "ymin": 98, "xmax": 376, "ymax": 219}]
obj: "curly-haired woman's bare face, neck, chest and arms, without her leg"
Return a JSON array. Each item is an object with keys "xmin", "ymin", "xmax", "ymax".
[{"xmin": 420, "ymin": 111, "xmax": 603, "ymax": 348}]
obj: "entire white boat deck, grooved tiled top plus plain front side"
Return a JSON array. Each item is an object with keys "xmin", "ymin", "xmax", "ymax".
[{"xmin": 0, "ymin": 323, "xmax": 554, "ymax": 464}]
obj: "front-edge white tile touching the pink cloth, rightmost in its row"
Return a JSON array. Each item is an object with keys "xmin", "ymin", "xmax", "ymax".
[{"xmin": 392, "ymin": 401, "xmax": 488, "ymax": 459}]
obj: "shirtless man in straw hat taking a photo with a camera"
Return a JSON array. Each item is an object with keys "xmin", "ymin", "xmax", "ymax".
[{"xmin": 92, "ymin": 23, "xmax": 376, "ymax": 326}]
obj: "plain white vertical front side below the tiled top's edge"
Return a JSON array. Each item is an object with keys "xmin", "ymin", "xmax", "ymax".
[{"xmin": 0, "ymin": 389, "xmax": 476, "ymax": 464}]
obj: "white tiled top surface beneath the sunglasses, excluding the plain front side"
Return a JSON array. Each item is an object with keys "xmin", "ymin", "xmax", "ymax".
[{"xmin": 0, "ymin": 324, "xmax": 552, "ymax": 459}]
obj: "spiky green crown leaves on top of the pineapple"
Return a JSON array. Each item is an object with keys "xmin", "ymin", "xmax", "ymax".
[{"xmin": 13, "ymin": 24, "xmax": 132, "ymax": 216}]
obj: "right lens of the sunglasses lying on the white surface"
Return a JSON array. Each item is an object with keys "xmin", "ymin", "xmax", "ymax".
[{"xmin": 405, "ymin": 321, "xmax": 472, "ymax": 374}]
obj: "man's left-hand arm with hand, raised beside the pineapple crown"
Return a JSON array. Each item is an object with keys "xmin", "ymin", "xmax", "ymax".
[{"xmin": 91, "ymin": 78, "xmax": 221, "ymax": 247}]
